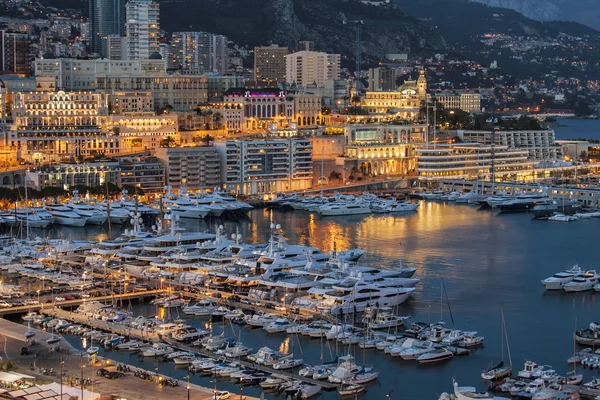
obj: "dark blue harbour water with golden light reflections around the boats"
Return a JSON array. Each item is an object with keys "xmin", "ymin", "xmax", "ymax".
[{"xmin": 25, "ymin": 202, "xmax": 600, "ymax": 399}]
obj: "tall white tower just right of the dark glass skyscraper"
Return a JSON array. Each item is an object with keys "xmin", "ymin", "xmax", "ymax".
[{"xmin": 125, "ymin": 0, "xmax": 160, "ymax": 60}]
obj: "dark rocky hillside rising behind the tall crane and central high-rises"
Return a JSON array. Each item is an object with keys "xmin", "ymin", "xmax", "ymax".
[{"xmin": 155, "ymin": 0, "xmax": 445, "ymax": 59}]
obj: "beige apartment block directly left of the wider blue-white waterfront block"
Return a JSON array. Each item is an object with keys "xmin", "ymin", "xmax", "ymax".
[{"xmin": 156, "ymin": 146, "xmax": 221, "ymax": 190}]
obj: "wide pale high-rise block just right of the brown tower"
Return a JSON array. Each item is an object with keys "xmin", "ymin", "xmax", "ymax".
[{"xmin": 286, "ymin": 51, "xmax": 340, "ymax": 87}]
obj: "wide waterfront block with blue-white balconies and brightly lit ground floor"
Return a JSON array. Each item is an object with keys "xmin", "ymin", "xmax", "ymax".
[{"xmin": 215, "ymin": 138, "xmax": 313, "ymax": 195}]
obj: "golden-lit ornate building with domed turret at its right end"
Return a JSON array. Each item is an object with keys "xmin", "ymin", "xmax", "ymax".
[{"xmin": 361, "ymin": 71, "xmax": 427, "ymax": 120}]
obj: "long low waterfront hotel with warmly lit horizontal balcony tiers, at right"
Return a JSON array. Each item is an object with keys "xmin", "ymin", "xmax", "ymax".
[{"xmin": 416, "ymin": 143, "xmax": 533, "ymax": 181}]
